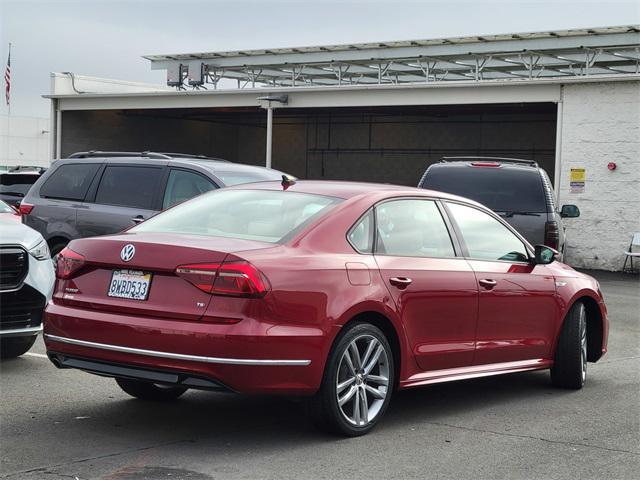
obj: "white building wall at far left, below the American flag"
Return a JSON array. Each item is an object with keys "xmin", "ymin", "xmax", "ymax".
[{"xmin": 0, "ymin": 115, "xmax": 50, "ymax": 168}]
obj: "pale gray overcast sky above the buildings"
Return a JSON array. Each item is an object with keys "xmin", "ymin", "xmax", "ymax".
[{"xmin": 0, "ymin": 0, "xmax": 640, "ymax": 117}]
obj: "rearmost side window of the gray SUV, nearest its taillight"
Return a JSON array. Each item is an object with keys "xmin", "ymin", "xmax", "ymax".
[{"xmin": 40, "ymin": 163, "xmax": 100, "ymax": 200}]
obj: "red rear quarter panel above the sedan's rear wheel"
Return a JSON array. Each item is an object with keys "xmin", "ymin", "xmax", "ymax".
[{"xmin": 238, "ymin": 247, "xmax": 417, "ymax": 385}]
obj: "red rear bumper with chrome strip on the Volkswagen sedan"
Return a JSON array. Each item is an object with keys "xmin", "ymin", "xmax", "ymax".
[{"xmin": 44, "ymin": 303, "xmax": 328, "ymax": 395}]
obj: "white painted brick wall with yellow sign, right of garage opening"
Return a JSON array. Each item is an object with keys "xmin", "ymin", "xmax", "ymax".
[{"xmin": 559, "ymin": 81, "xmax": 640, "ymax": 270}]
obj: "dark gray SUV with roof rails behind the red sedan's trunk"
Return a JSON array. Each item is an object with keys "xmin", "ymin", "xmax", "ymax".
[{"xmin": 20, "ymin": 152, "xmax": 283, "ymax": 256}]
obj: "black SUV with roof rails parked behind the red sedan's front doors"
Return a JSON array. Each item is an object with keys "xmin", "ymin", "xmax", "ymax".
[{"xmin": 418, "ymin": 157, "xmax": 580, "ymax": 254}]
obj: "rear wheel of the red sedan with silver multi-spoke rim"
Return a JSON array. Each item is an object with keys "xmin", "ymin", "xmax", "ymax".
[{"xmin": 309, "ymin": 322, "xmax": 395, "ymax": 437}]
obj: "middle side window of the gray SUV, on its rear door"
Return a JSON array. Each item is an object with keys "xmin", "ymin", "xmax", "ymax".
[{"xmin": 95, "ymin": 165, "xmax": 162, "ymax": 210}]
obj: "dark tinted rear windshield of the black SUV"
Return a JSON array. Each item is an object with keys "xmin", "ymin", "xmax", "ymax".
[{"xmin": 421, "ymin": 165, "xmax": 547, "ymax": 213}]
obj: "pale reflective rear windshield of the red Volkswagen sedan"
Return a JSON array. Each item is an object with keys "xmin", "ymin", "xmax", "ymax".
[{"xmin": 129, "ymin": 190, "xmax": 342, "ymax": 243}]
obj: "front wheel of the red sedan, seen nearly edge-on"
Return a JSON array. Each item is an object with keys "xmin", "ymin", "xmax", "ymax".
[{"xmin": 551, "ymin": 302, "xmax": 587, "ymax": 390}]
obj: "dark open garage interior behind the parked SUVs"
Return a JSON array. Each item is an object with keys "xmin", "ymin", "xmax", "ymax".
[{"xmin": 61, "ymin": 103, "xmax": 556, "ymax": 186}]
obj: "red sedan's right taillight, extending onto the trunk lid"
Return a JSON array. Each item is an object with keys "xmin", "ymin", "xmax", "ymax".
[{"xmin": 176, "ymin": 260, "xmax": 270, "ymax": 297}]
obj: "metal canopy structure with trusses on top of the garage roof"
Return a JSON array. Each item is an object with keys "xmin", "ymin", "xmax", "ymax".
[{"xmin": 144, "ymin": 25, "xmax": 640, "ymax": 90}]
